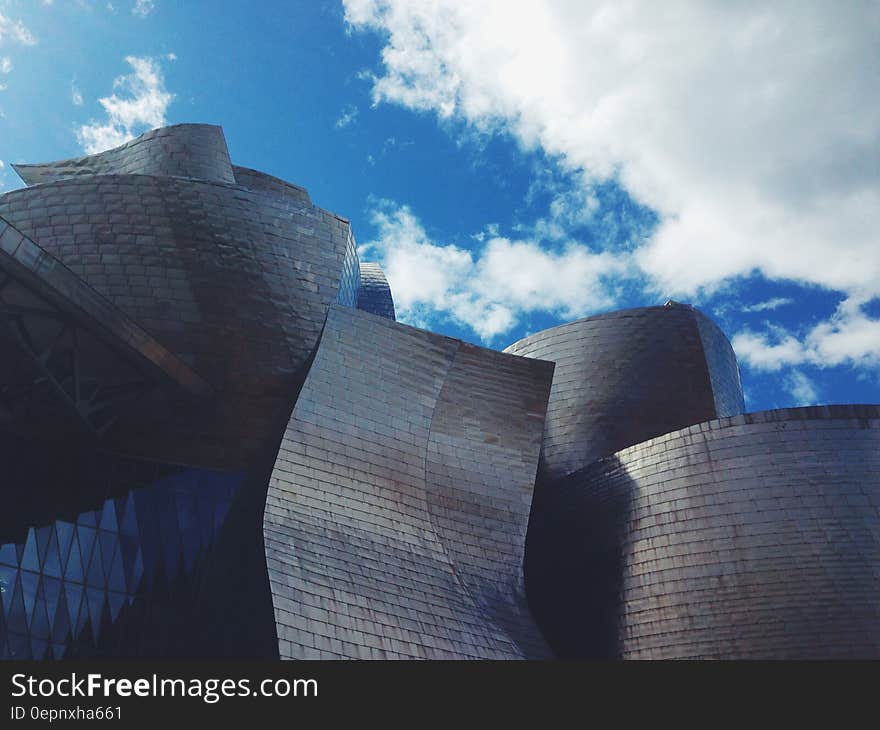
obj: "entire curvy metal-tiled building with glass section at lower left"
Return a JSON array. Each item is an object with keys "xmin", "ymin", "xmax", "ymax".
[{"xmin": 0, "ymin": 125, "xmax": 880, "ymax": 659}]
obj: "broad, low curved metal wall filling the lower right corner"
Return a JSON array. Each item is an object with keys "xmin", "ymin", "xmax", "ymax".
[{"xmin": 526, "ymin": 406, "xmax": 880, "ymax": 659}]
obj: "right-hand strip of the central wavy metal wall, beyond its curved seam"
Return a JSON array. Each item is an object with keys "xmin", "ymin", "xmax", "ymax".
[{"xmin": 425, "ymin": 343, "xmax": 553, "ymax": 658}]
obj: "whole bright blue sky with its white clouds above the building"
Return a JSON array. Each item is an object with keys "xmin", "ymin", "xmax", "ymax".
[{"xmin": 0, "ymin": 0, "xmax": 880, "ymax": 410}]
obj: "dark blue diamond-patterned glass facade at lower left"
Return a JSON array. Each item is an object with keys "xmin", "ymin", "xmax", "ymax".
[{"xmin": 0, "ymin": 442, "xmax": 242, "ymax": 659}]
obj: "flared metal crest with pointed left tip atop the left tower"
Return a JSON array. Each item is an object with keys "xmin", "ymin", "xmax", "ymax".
[{"xmin": 13, "ymin": 124, "xmax": 235, "ymax": 185}]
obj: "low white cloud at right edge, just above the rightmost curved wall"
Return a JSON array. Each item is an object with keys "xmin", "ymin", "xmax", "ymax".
[{"xmin": 731, "ymin": 299, "xmax": 880, "ymax": 371}]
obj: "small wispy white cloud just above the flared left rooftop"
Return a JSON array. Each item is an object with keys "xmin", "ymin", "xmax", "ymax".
[{"xmin": 77, "ymin": 56, "xmax": 174, "ymax": 154}]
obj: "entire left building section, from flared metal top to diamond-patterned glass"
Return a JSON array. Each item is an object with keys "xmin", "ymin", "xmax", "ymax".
[{"xmin": 0, "ymin": 125, "xmax": 359, "ymax": 658}]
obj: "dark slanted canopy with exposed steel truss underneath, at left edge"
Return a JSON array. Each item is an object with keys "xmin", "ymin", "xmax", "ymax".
[{"xmin": 0, "ymin": 218, "xmax": 213, "ymax": 440}]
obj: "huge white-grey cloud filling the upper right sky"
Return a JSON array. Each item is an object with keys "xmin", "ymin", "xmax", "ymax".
[{"xmin": 345, "ymin": 0, "xmax": 880, "ymax": 302}]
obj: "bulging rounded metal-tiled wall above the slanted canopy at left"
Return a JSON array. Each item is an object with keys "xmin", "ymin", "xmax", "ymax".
[{"xmin": 0, "ymin": 175, "xmax": 357, "ymax": 468}]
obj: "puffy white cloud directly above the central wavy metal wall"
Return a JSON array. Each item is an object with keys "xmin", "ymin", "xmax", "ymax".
[{"xmin": 361, "ymin": 201, "xmax": 625, "ymax": 341}]
